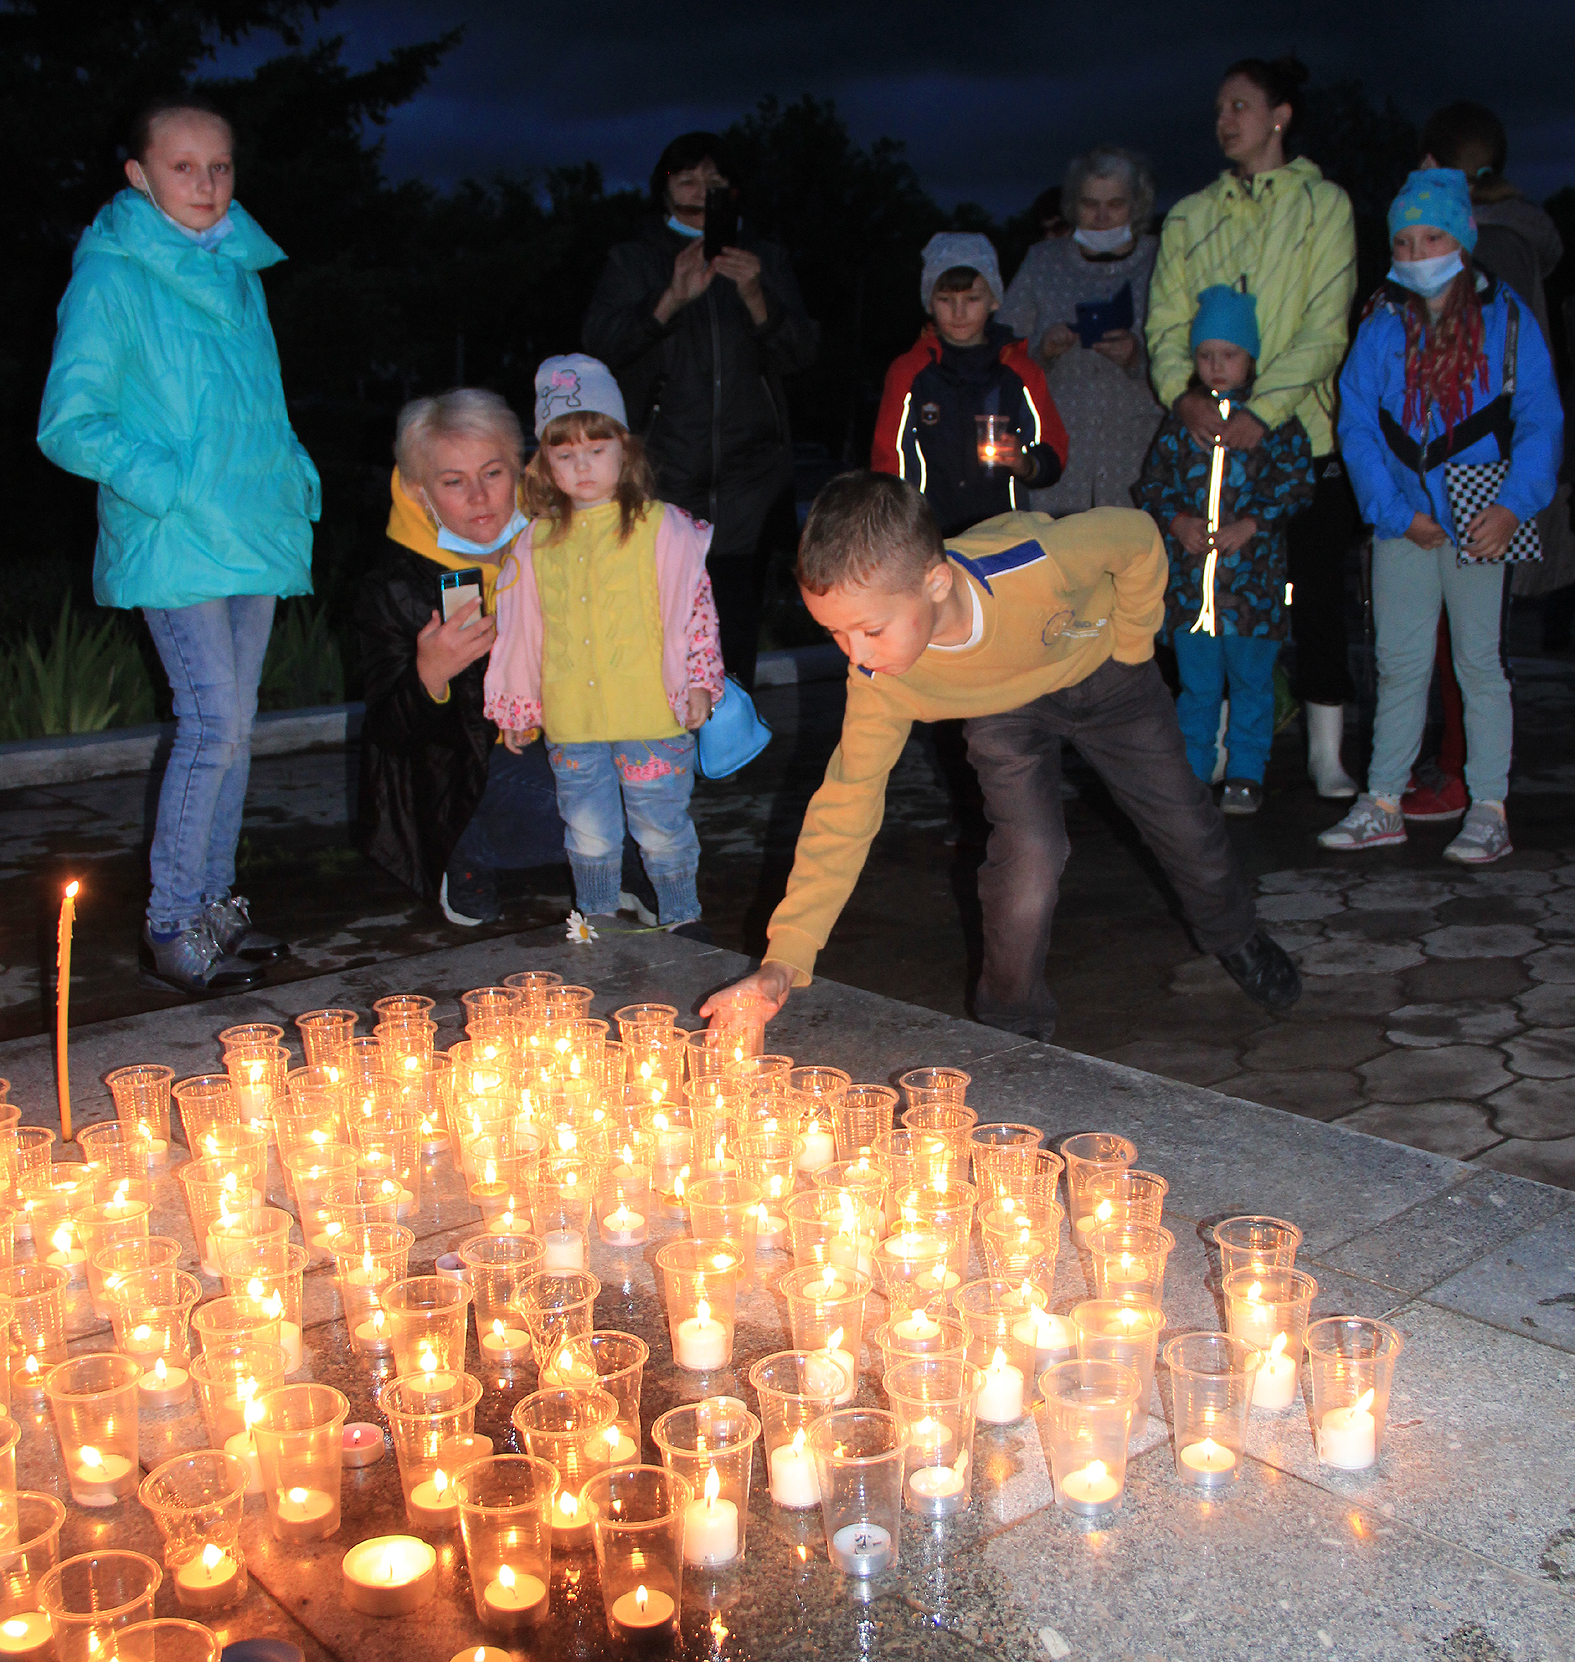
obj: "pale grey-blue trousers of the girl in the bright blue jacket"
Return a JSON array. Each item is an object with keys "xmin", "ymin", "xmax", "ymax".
[{"xmin": 1367, "ymin": 537, "xmax": 1515, "ymax": 803}]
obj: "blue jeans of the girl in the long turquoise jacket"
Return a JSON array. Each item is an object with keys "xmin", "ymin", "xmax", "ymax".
[{"xmin": 143, "ymin": 595, "xmax": 274, "ymax": 934}]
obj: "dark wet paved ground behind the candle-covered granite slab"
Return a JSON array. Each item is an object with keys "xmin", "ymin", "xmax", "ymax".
[{"xmin": 0, "ymin": 612, "xmax": 1575, "ymax": 1188}]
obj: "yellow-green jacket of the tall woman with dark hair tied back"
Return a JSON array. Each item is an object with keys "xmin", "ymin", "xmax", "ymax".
[{"xmin": 1145, "ymin": 158, "xmax": 1356, "ymax": 455}]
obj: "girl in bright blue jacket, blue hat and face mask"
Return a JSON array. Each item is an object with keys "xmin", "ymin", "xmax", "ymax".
[{"xmin": 1319, "ymin": 168, "xmax": 1563, "ymax": 866}]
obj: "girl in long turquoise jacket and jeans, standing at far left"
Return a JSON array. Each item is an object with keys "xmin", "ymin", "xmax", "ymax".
[{"xmin": 38, "ymin": 103, "xmax": 321, "ymax": 994}]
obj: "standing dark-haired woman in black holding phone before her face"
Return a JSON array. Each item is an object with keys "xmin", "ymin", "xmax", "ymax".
[{"xmin": 583, "ymin": 133, "xmax": 819, "ymax": 686}]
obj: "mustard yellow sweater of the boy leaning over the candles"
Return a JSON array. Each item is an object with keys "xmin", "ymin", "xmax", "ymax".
[{"xmin": 766, "ymin": 509, "xmax": 1168, "ymax": 987}]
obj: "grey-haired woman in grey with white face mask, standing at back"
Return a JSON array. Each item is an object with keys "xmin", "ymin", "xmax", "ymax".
[{"xmin": 1000, "ymin": 145, "xmax": 1161, "ymax": 514}]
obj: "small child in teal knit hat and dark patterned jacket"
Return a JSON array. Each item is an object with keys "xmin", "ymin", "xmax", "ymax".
[{"xmin": 1131, "ymin": 284, "xmax": 1314, "ymax": 814}]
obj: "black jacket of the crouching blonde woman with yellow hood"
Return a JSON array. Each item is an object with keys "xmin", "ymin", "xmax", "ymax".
[{"xmin": 356, "ymin": 540, "xmax": 498, "ymax": 901}]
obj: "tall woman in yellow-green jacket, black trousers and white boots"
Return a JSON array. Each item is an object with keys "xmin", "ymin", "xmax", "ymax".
[{"xmin": 1146, "ymin": 58, "xmax": 1357, "ymax": 796}]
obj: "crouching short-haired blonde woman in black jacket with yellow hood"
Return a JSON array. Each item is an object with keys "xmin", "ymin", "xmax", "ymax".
[{"xmin": 356, "ymin": 387, "xmax": 571, "ymax": 926}]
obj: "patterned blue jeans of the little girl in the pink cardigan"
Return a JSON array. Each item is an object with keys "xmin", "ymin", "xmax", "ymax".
[{"xmin": 547, "ymin": 733, "xmax": 699, "ymax": 924}]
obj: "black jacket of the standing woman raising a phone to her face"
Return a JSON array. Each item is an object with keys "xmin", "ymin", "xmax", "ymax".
[{"xmin": 583, "ymin": 221, "xmax": 819, "ymax": 558}]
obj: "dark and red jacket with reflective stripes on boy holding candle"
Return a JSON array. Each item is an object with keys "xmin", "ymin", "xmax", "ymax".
[{"xmin": 869, "ymin": 322, "xmax": 1067, "ymax": 537}]
